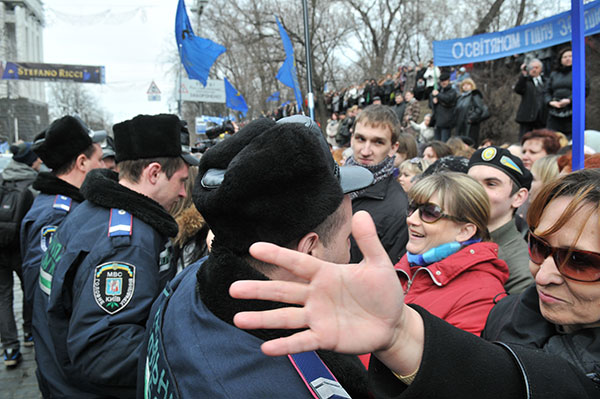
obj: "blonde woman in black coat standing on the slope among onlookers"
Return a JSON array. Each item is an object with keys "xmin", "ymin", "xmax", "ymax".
[{"xmin": 454, "ymin": 78, "xmax": 489, "ymax": 143}]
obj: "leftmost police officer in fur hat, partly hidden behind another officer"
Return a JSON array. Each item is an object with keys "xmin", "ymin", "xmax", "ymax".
[{"xmin": 20, "ymin": 116, "xmax": 106, "ymax": 387}]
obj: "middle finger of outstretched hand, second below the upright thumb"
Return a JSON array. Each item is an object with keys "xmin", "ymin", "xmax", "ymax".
[{"xmin": 229, "ymin": 280, "xmax": 308, "ymax": 305}]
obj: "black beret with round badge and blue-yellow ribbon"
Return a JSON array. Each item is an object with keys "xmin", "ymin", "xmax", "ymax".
[{"xmin": 469, "ymin": 146, "xmax": 533, "ymax": 190}]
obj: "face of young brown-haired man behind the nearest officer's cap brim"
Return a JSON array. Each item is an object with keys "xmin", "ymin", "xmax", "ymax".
[{"xmin": 350, "ymin": 121, "xmax": 398, "ymax": 166}]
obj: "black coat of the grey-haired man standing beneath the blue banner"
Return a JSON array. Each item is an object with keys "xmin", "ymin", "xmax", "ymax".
[{"xmin": 515, "ymin": 74, "xmax": 547, "ymax": 126}]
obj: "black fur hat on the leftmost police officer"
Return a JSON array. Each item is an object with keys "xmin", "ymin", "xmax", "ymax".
[{"xmin": 32, "ymin": 115, "xmax": 106, "ymax": 169}]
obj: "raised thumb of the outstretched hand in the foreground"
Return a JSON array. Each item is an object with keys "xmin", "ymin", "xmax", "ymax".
[{"xmin": 352, "ymin": 211, "xmax": 391, "ymax": 267}]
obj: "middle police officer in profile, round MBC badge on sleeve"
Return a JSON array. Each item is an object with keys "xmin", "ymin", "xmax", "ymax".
[{"xmin": 34, "ymin": 114, "xmax": 196, "ymax": 398}]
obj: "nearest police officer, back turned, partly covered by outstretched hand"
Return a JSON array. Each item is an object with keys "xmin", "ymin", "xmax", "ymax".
[{"xmin": 138, "ymin": 116, "xmax": 373, "ymax": 399}]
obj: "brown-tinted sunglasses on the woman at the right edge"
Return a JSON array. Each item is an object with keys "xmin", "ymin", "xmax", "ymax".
[{"xmin": 529, "ymin": 230, "xmax": 600, "ymax": 282}]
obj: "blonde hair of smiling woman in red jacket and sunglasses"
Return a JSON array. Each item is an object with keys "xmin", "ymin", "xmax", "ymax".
[{"xmin": 408, "ymin": 172, "xmax": 490, "ymax": 240}]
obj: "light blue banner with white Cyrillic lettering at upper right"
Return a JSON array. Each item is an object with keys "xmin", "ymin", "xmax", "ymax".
[{"xmin": 433, "ymin": 0, "xmax": 600, "ymax": 66}]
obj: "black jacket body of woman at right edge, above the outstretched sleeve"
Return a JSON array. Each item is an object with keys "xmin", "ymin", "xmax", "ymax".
[{"xmin": 482, "ymin": 285, "xmax": 600, "ymax": 388}]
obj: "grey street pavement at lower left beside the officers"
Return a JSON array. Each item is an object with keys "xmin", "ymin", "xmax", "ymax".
[{"xmin": 0, "ymin": 274, "xmax": 42, "ymax": 399}]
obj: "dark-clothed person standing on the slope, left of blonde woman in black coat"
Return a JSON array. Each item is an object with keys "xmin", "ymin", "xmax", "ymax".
[{"xmin": 429, "ymin": 72, "xmax": 458, "ymax": 142}]
